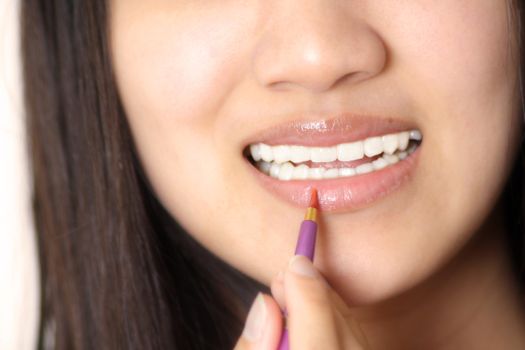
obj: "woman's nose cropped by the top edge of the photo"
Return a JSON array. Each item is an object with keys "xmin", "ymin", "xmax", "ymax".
[{"xmin": 252, "ymin": 0, "xmax": 386, "ymax": 92}]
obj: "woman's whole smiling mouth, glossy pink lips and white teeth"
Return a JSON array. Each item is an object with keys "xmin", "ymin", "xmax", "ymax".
[{"xmin": 243, "ymin": 115, "xmax": 423, "ymax": 211}]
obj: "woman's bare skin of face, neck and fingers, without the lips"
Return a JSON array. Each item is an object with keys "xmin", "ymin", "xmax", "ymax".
[{"xmin": 111, "ymin": 0, "xmax": 525, "ymax": 349}]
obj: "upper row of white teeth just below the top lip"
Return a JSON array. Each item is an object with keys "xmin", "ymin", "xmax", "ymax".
[{"xmin": 250, "ymin": 130, "xmax": 422, "ymax": 164}]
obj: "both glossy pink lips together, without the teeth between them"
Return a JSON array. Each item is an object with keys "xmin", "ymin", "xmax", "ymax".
[{"xmin": 245, "ymin": 116, "xmax": 422, "ymax": 212}]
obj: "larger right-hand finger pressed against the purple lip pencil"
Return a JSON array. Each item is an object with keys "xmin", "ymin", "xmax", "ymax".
[{"xmin": 284, "ymin": 255, "xmax": 344, "ymax": 350}]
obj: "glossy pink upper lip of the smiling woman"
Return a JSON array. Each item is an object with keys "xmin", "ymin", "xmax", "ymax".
[{"xmin": 241, "ymin": 113, "xmax": 417, "ymax": 147}]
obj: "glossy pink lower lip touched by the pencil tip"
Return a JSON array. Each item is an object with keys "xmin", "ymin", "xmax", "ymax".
[{"xmin": 247, "ymin": 146, "xmax": 421, "ymax": 212}]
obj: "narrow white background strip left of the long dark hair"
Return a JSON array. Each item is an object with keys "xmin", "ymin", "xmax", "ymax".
[{"xmin": 0, "ymin": 0, "xmax": 39, "ymax": 350}]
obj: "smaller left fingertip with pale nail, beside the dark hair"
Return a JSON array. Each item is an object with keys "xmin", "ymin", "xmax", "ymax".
[{"xmin": 234, "ymin": 293, "xmax": 283, "ymax": 350}]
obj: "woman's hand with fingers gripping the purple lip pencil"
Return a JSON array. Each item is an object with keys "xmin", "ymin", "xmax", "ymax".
[{"xmin": 235, "ymin": 256, "xmax": 367, "ymax": 350}]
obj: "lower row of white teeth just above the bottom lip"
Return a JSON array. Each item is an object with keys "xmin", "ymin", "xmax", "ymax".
[{"xmin": 257, "ymin": 145, "xmax": 417, "ymax": 181}]
